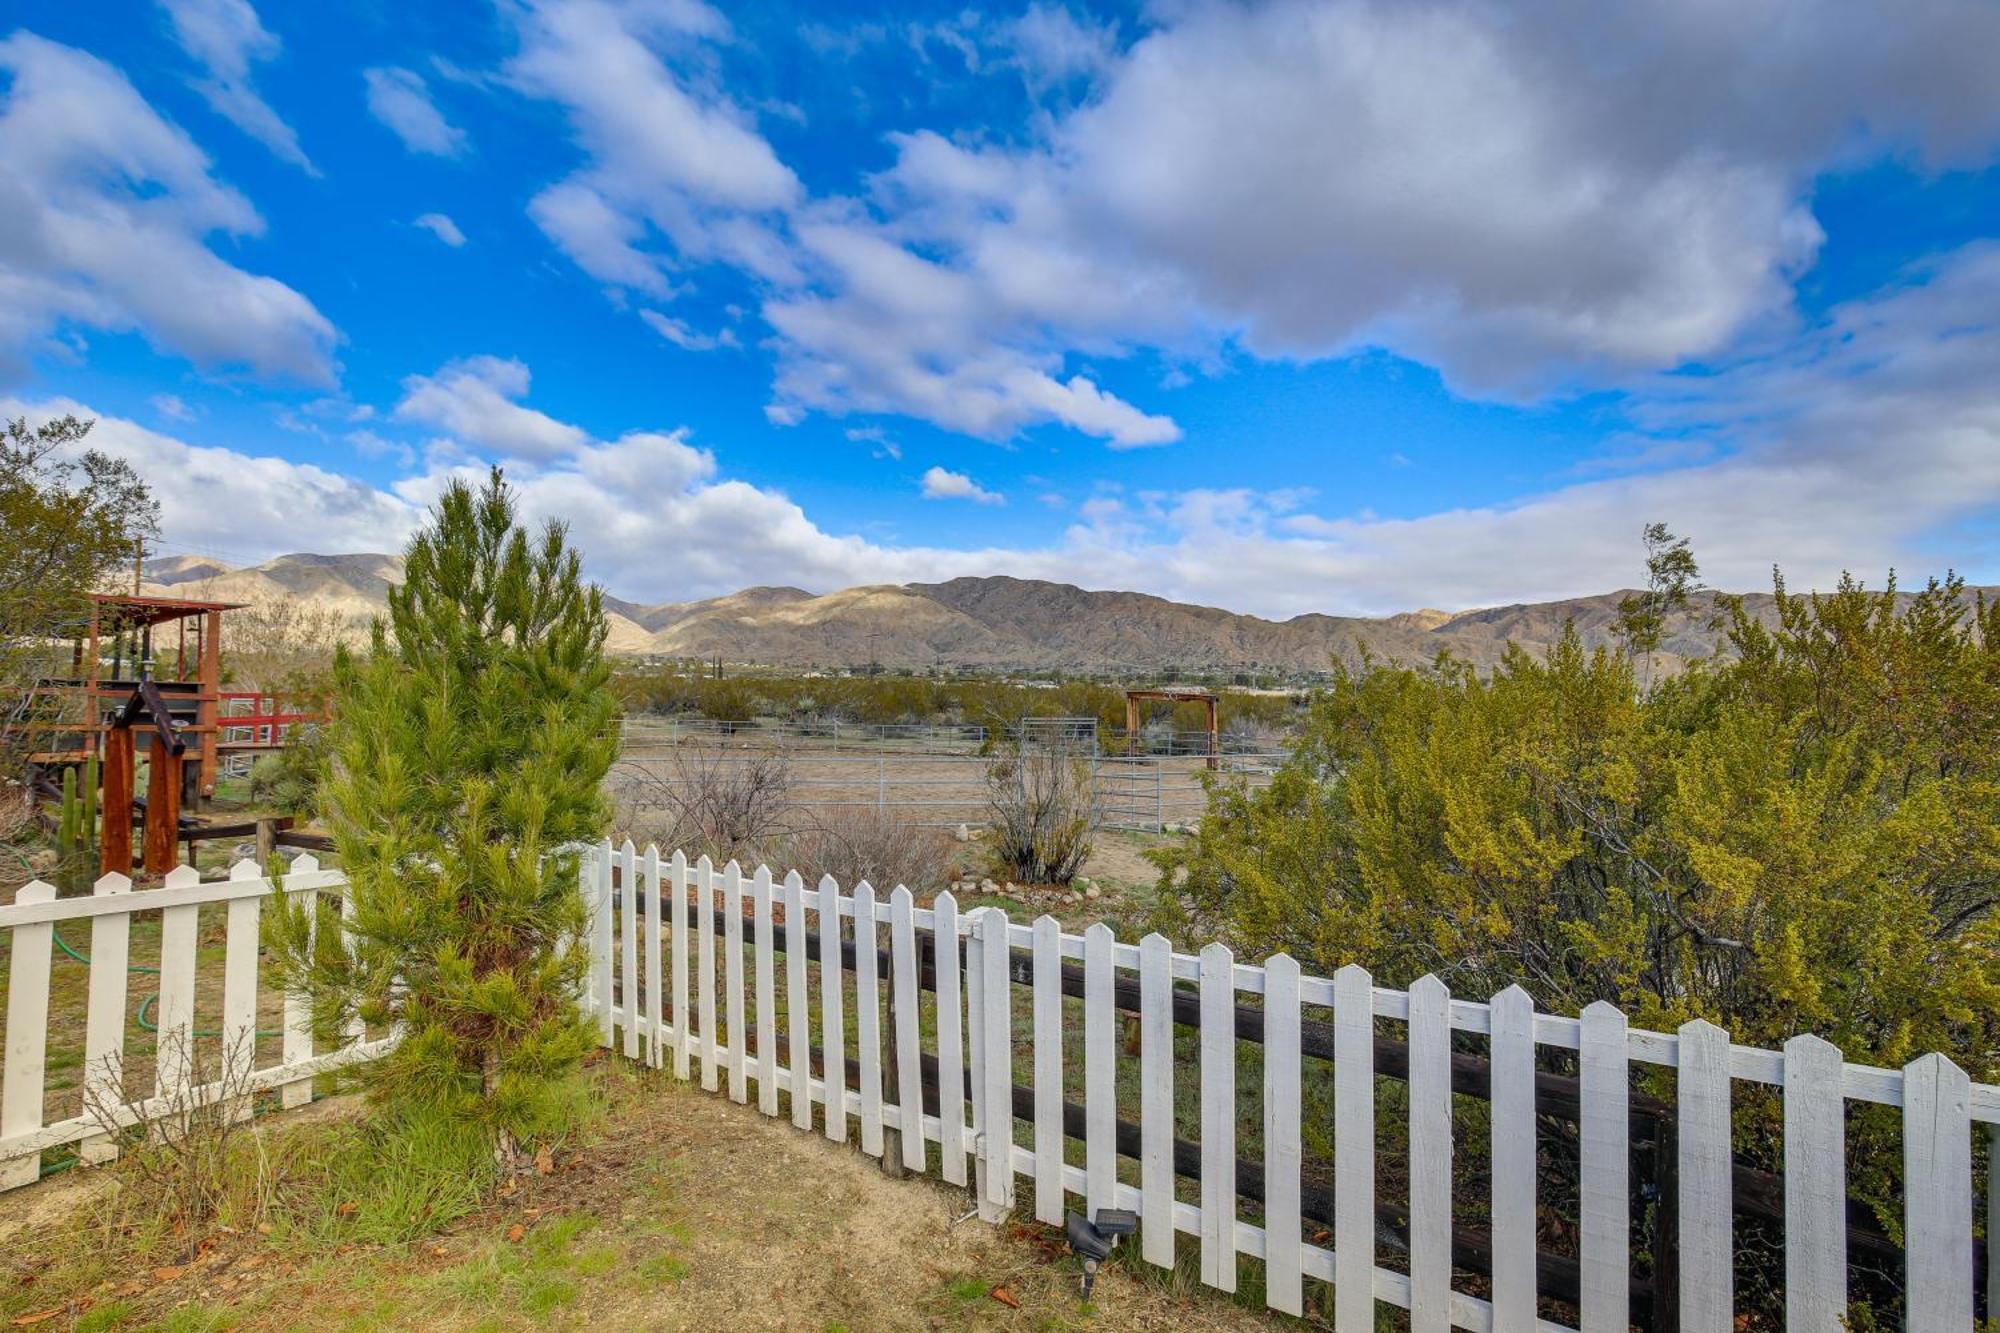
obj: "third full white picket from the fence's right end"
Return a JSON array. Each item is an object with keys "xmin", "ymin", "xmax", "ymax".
[{"xmin": 1678, "ymin": 1019, "xmax": 1736, "ymax": 1333}]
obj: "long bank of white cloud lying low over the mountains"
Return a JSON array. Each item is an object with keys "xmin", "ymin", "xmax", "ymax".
[{"xmin": 15, "ymin": 244, "xmax": 2000, "ymax": 616}]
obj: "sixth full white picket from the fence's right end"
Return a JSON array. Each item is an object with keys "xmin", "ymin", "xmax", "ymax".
[{"xmin": 1410, "ymin": 964, "xmax": 1452, "ymax": 1333}]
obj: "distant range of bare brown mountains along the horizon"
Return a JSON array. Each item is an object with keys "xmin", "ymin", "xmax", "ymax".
[{"xmin": 148, "ymin": 554, "xmax": 1984, "ymax": 673}]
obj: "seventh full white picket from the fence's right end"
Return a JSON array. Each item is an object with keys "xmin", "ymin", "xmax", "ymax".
[{"xmin": 1334, "ymin": 963, "xmax": 1376, "ymax": 1333}]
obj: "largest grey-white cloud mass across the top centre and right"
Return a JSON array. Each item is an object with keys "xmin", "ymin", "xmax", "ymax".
[{"xmin": 512, "ymin": 0, "xmax": 2000, "ymax": 444}]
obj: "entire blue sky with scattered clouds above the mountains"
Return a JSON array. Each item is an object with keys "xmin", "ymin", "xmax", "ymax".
[{"xmin": 0, "ymin": 0, "xmax": 2000, "ymax": 616}]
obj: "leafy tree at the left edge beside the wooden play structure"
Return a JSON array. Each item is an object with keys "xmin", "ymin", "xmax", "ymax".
[{"xmin": 0, "ymin": 416, "xmax": 160, "ymax": 764}]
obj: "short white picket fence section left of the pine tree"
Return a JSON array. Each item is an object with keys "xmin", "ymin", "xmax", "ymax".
[{"xmin": 0, "ymin": 857, "xmax": 390, "ymax": 1191}]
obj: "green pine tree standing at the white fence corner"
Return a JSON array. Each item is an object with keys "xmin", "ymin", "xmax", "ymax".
[{"xmin": 272, "ymin": 470, "xmax": 616, "ymax": 1155}]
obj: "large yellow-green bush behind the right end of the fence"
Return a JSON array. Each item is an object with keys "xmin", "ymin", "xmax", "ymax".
[{"xmin": 1162, "ymin": 578, "xmax": 2000, "ymax": 1077}]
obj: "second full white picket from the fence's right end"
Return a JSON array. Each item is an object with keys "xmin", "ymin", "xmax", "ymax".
[{"xmin": 1784, "ymin": 1037, "xmax": 1848, "ymax": 1333}]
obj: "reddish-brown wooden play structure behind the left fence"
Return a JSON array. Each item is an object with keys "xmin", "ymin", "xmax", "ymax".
[{"xmin": 32, "ymin": 594, "xmax": 322, "ymax": 875}]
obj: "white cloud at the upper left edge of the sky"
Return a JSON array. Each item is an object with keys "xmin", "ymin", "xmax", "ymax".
[{"xmin": 0, "ymin": 32, "xmax": 336, "ymax": 384}]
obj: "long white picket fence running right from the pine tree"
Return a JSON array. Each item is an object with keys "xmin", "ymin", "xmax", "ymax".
[{"xmin": 582, "ymin": 843, "xmax": 2000, "ymax": 1333}]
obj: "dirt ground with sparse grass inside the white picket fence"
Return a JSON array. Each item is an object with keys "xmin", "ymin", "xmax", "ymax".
[{"xmin": 0, "ymin": 1063, "xmax": 1298, "ymax": 1333}]
